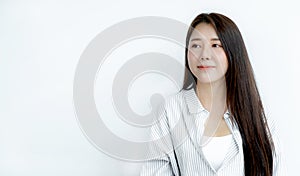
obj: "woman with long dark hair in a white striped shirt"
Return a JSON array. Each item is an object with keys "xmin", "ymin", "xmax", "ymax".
[{"xmin": 141, "ymin": 13, "xmax": 282, "ymax": 176}]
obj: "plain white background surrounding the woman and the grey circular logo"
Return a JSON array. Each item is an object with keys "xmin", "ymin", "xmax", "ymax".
[{"xmin": 0, "ymin": 0, "xmax": 300, "ymax": 176}]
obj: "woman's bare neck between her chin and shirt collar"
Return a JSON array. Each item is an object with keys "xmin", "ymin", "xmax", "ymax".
[{"xmin": 196, "ymin": 78, "xmax": 227, "ymax": 113}]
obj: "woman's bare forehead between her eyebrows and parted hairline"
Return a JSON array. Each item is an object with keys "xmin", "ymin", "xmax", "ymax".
[{"xmin": 191, "ymin": 23, "xmax": 218, "ymax": 40}]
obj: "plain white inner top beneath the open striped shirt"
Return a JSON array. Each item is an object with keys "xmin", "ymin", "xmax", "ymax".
[{"xmin": 202, "ymin": 134, "xmax": 233, "ymax": 170}]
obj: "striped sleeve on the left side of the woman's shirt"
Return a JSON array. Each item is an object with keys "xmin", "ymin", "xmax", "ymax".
[{"xmin": 140, "ymin": 100, "xmax": 177, "ymax": 176}]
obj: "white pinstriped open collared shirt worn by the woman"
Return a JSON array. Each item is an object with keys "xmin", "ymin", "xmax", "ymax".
[{"xmin": 140, "ymin": 89, "xmax": 284, "ymax": 176}]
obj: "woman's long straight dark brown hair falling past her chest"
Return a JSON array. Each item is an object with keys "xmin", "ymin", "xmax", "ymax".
[{"xmin": 183, "ymin": 13, "xmax": 274, "ymax": 176}]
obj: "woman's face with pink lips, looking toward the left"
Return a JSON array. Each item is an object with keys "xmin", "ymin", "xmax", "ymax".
[{"xmin": 188, "ymin": 23, "xmax": 228, "ymax": 84}]
